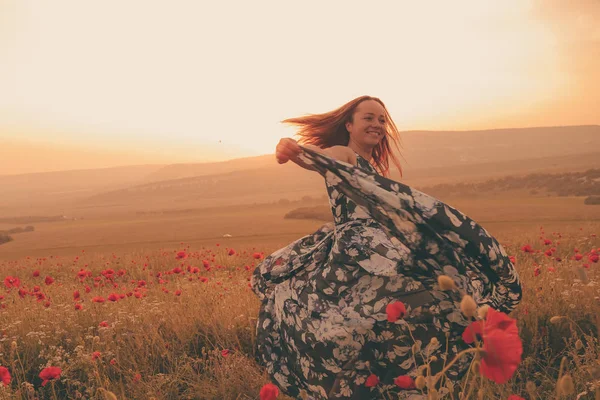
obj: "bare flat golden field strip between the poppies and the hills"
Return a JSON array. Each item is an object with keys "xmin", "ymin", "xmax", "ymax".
[{"xmin": 0, "ymin": 191, "xmax": 600, "ymax": 259}]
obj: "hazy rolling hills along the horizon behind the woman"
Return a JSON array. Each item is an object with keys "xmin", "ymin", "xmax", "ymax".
[{"xmin": 0, "ymin": 125, "xmax": 600, "ymax": 215}]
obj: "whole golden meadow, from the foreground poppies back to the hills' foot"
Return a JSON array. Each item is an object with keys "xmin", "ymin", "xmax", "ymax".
[{"xmin": 0, "ymin": 193, "xmax": 600, "ymax": 399}]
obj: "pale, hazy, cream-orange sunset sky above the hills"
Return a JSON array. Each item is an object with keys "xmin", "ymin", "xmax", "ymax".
[{"xmin": 0, "ymin": 0, "xmax": 600, "ymax": 174}]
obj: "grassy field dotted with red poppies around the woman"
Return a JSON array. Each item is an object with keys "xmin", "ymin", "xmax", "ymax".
[{"xmin": 0, "ymin": 216, "xmax": 600, "ymax": 400}]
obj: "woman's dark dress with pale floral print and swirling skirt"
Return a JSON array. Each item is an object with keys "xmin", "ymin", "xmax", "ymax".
[{"xmin": 251, "ymin": 146, "xmax": 521, "ymax": 400}]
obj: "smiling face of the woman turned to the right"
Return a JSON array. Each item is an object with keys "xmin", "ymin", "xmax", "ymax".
[{"xmin": 346, "ymin": 100, "xmax": 386, "ymax": 147}]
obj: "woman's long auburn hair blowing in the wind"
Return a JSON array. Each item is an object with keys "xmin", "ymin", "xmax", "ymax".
[{"xmin": 281, "ymin": 96, "xmax": 402, "ymax": 177}]
